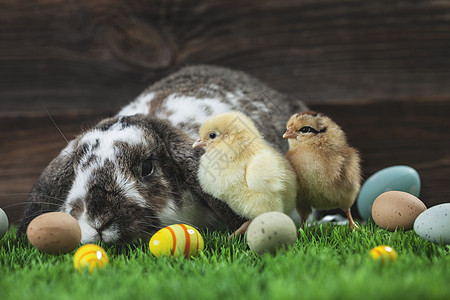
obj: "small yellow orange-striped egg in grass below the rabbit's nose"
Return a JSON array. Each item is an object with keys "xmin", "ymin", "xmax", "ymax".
[{"xmin": 73, "ymin": 244, "xmax": 109, "ymax": 273}]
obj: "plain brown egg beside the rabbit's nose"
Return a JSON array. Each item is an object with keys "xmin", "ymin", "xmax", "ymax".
[{"xmin": 27, "ymin": 212, "xmax": 81, "ymax": 254}]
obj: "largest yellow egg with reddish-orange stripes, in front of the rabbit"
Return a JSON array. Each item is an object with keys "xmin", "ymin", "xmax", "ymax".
[{"xmin": 149, "ymin": 224, "xmax": 205, "ymax": 257}]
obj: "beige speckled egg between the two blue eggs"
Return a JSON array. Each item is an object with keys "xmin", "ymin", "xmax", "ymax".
[{"xmin": 372, "ymin": 191, "xmax": 427, "ymax": 231}]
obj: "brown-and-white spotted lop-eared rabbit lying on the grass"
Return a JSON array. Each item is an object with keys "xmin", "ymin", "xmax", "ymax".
[{"xmin": 18, "ymin": 65, "xmax": 307, "ymax": 244}]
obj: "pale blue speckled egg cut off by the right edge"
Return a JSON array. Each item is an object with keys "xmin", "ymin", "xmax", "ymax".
[{"xmin": 414, "ymin": 203, "xmax": 450, "ymax": 244}]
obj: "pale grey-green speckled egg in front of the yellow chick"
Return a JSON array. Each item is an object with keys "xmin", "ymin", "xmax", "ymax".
[{"xmin": 247, "ymin": 211, "xmax": 297, "ymax": 254}]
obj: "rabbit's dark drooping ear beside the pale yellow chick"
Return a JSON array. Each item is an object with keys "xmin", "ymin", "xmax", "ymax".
[{"xmin": 155, "ymin": 122, "xmax": 247, "ymax": 231}]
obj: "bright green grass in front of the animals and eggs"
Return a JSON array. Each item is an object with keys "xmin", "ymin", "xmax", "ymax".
[{"xmin": 0, "ymin": 224, "xmax": 450, "ymax": 300}]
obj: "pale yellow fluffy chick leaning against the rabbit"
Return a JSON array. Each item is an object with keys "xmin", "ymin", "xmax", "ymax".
[{"xmin": 192, "ymin": 112, "xmax": 297, "ymax": 234}]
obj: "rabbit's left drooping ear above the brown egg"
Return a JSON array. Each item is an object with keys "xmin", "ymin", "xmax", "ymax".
[{"xmin": 17, "ymin": 140, "xmax": 76, "ymax": 235}]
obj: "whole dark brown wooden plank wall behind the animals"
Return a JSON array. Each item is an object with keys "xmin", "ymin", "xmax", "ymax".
[{"xmin": 0, "ymin": 0, "xmax": 450, "ymax": 222}]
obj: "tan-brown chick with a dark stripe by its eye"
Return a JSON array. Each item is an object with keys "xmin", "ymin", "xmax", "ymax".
[{"xmin": 283, "ymin": 112, "xmax": 361, "ymax": 230}]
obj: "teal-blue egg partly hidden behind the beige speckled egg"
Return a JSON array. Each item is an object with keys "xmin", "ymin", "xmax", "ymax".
[{"xmin": 356, "ymin": 166, "xmax": 420, "ymax": 220}]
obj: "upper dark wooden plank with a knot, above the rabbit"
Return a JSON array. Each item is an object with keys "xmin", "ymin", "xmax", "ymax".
[{"xmin": 0, "ymin": 0, "xmax": 450, "ymax": 115}]
